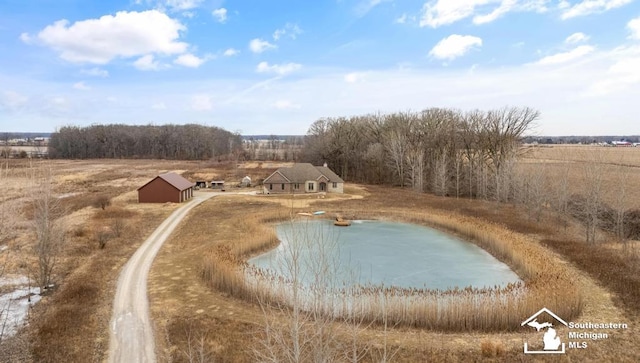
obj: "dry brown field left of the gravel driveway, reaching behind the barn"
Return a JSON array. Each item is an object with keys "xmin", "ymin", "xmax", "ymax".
[{"xmin": 0, "ymin": 159, "xmax": 271, "ymax": 362}]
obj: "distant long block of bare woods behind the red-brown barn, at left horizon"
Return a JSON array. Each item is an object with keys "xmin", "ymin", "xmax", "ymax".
[{"xmin": 49, "ymin": 124, "xmax": 242, "ymax": 160}]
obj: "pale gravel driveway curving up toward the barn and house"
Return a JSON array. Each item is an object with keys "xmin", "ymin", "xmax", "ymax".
[{"xmin": 109, "ymin": 193, "xmax": 219, "ymax": 363}]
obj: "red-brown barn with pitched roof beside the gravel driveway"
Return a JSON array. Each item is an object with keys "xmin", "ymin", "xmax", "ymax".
[{"xmin": 138, "ymin": 173, "xmax": 195, "ymax": 203}]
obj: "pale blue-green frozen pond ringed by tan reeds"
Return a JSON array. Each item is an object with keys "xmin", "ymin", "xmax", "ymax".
[{"xmin": 249, "ymin": 219, "xmax": 520, "ymax": 289}]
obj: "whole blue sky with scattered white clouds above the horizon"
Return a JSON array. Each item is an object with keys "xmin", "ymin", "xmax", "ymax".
[{"xmin": 0, "ymin": 0, "xmax": 640, "ymax": 135}]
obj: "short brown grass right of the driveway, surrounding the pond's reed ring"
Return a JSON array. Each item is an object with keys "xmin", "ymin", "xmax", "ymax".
[{"xmin": 150, "ymin": 187, "xmax": 638, "ymax": 362}]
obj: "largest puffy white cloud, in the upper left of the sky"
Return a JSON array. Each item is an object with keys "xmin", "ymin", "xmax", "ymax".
[{"xmin": 29, "ymin": 10, "xmax": 188, "ymax": 64}]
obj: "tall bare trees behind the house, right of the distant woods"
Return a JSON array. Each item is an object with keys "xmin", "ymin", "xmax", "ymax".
[{"xmin": 303, "ymin": 107, "xmax": 540, "ymax": 201}]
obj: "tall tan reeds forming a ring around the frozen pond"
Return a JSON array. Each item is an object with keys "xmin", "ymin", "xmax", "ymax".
[{"xmin": 202, "ymin": 211, "xmax": 582, "ymax": 331}]
